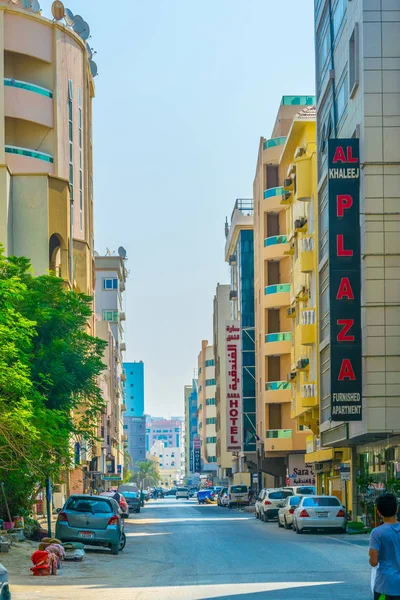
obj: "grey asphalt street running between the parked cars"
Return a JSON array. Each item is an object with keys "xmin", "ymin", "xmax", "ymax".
[{"xmin": 11, "ymin": 498, "xmax": 370, "ymax": 600}]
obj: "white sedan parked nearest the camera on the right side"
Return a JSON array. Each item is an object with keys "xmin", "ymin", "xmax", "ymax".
[{"xmin": 293, "ymin": 496, "xmax": 347, "ymax": 533}]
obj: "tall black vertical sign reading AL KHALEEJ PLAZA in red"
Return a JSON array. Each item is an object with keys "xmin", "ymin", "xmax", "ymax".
[{"xmin": 328, "ymin": 138, "xmax": 362, "ymax": 421}]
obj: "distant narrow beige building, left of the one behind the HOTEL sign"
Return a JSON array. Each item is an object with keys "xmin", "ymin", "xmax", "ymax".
[{"xmin": 197, "ymin": 340, "xmax": 218, "ymax": 477}]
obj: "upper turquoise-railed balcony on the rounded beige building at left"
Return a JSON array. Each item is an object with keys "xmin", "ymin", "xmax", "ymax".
[{"xmin": 4, "ymin": 77, "xmax": 54, "ymax": 129}]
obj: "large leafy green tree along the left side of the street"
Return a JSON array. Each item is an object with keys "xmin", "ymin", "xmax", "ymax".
[{"xmin": 0, "ymin": 248, "xmax": 106, "ymax": 514}]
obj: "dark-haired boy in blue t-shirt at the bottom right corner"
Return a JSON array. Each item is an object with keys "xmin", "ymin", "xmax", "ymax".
[{"xmin": 369, "ymin": 494, "xmax": 400, "ymax": 600}]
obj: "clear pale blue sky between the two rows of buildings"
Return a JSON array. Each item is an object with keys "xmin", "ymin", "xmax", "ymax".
[{"xmin": 41, "ymin": 0, "xmax": 315, "ymax": 415}]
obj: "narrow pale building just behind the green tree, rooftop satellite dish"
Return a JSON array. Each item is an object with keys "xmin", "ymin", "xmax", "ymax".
[{"xmin": 92, "ymin": 253, "xmax": 127, "ymax": 476}]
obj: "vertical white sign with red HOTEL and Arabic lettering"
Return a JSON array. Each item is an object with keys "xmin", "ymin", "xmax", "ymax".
[{"xmin": 225, "ymin": 321, "xmax": 243, "ymax": 452}]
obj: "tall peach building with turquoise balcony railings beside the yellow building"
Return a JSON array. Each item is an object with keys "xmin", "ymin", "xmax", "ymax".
[{"xmin": 253, "ymin": 96, "xmax": 315, "ymax": 485}]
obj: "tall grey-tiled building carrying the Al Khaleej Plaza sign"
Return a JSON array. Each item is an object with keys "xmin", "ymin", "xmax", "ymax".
[{"xmin": 312, "ymin": 0, "xmax": 400, "ymax": 514}]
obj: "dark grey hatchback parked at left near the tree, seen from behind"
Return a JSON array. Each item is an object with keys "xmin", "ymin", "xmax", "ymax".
[{"xmin": 55, "ymin": 494, "xmax": 126, "ymax": 554}]
